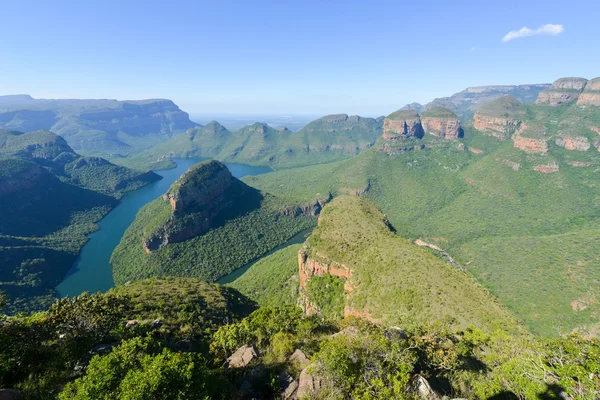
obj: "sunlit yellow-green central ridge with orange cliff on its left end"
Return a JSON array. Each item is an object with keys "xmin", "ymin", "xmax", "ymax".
[{"xmin": 298, "ymin": 196, "xmax": 518, "ymax": 332}]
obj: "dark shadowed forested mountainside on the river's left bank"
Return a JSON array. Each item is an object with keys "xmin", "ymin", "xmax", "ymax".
[{"xmin": 0, "ymin": 131, "xmax": 160, "ymax": 312}]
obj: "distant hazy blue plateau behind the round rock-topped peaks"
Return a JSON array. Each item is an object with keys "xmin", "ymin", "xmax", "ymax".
[{"xmin": 422, "ymin": 83, "xmax": 550, "ymax": 118}]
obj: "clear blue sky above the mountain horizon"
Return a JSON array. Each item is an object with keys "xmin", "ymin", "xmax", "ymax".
[{"xmin": 0, "ymin": 0, "xmax": 600, "ymax": 115}]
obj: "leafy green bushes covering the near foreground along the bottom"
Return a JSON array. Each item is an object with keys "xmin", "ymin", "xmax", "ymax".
[{"xmin": 0, "ymin": 286, "xmax": 600, "ymax": 400}]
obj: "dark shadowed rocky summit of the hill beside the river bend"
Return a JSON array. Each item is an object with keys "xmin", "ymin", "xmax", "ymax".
[{"xmin": 142, "ymin": 160, "xmax": 251, "ymax": 253}]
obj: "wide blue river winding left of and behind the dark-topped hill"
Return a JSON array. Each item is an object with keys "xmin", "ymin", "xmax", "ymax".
[{"xmin": 56, "ymin": 158, "xmax": 272, "ymax": 297}]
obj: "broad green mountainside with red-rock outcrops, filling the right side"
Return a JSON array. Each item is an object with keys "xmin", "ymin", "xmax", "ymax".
[{"xmin": 244, "ymin": 80, "xmax": 600, "ymax": 336}]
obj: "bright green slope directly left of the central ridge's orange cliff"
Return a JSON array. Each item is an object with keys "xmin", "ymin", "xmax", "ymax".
[{"xmin": 228, "ymin": 244, "xmax": 302, "ymax": 307}]
